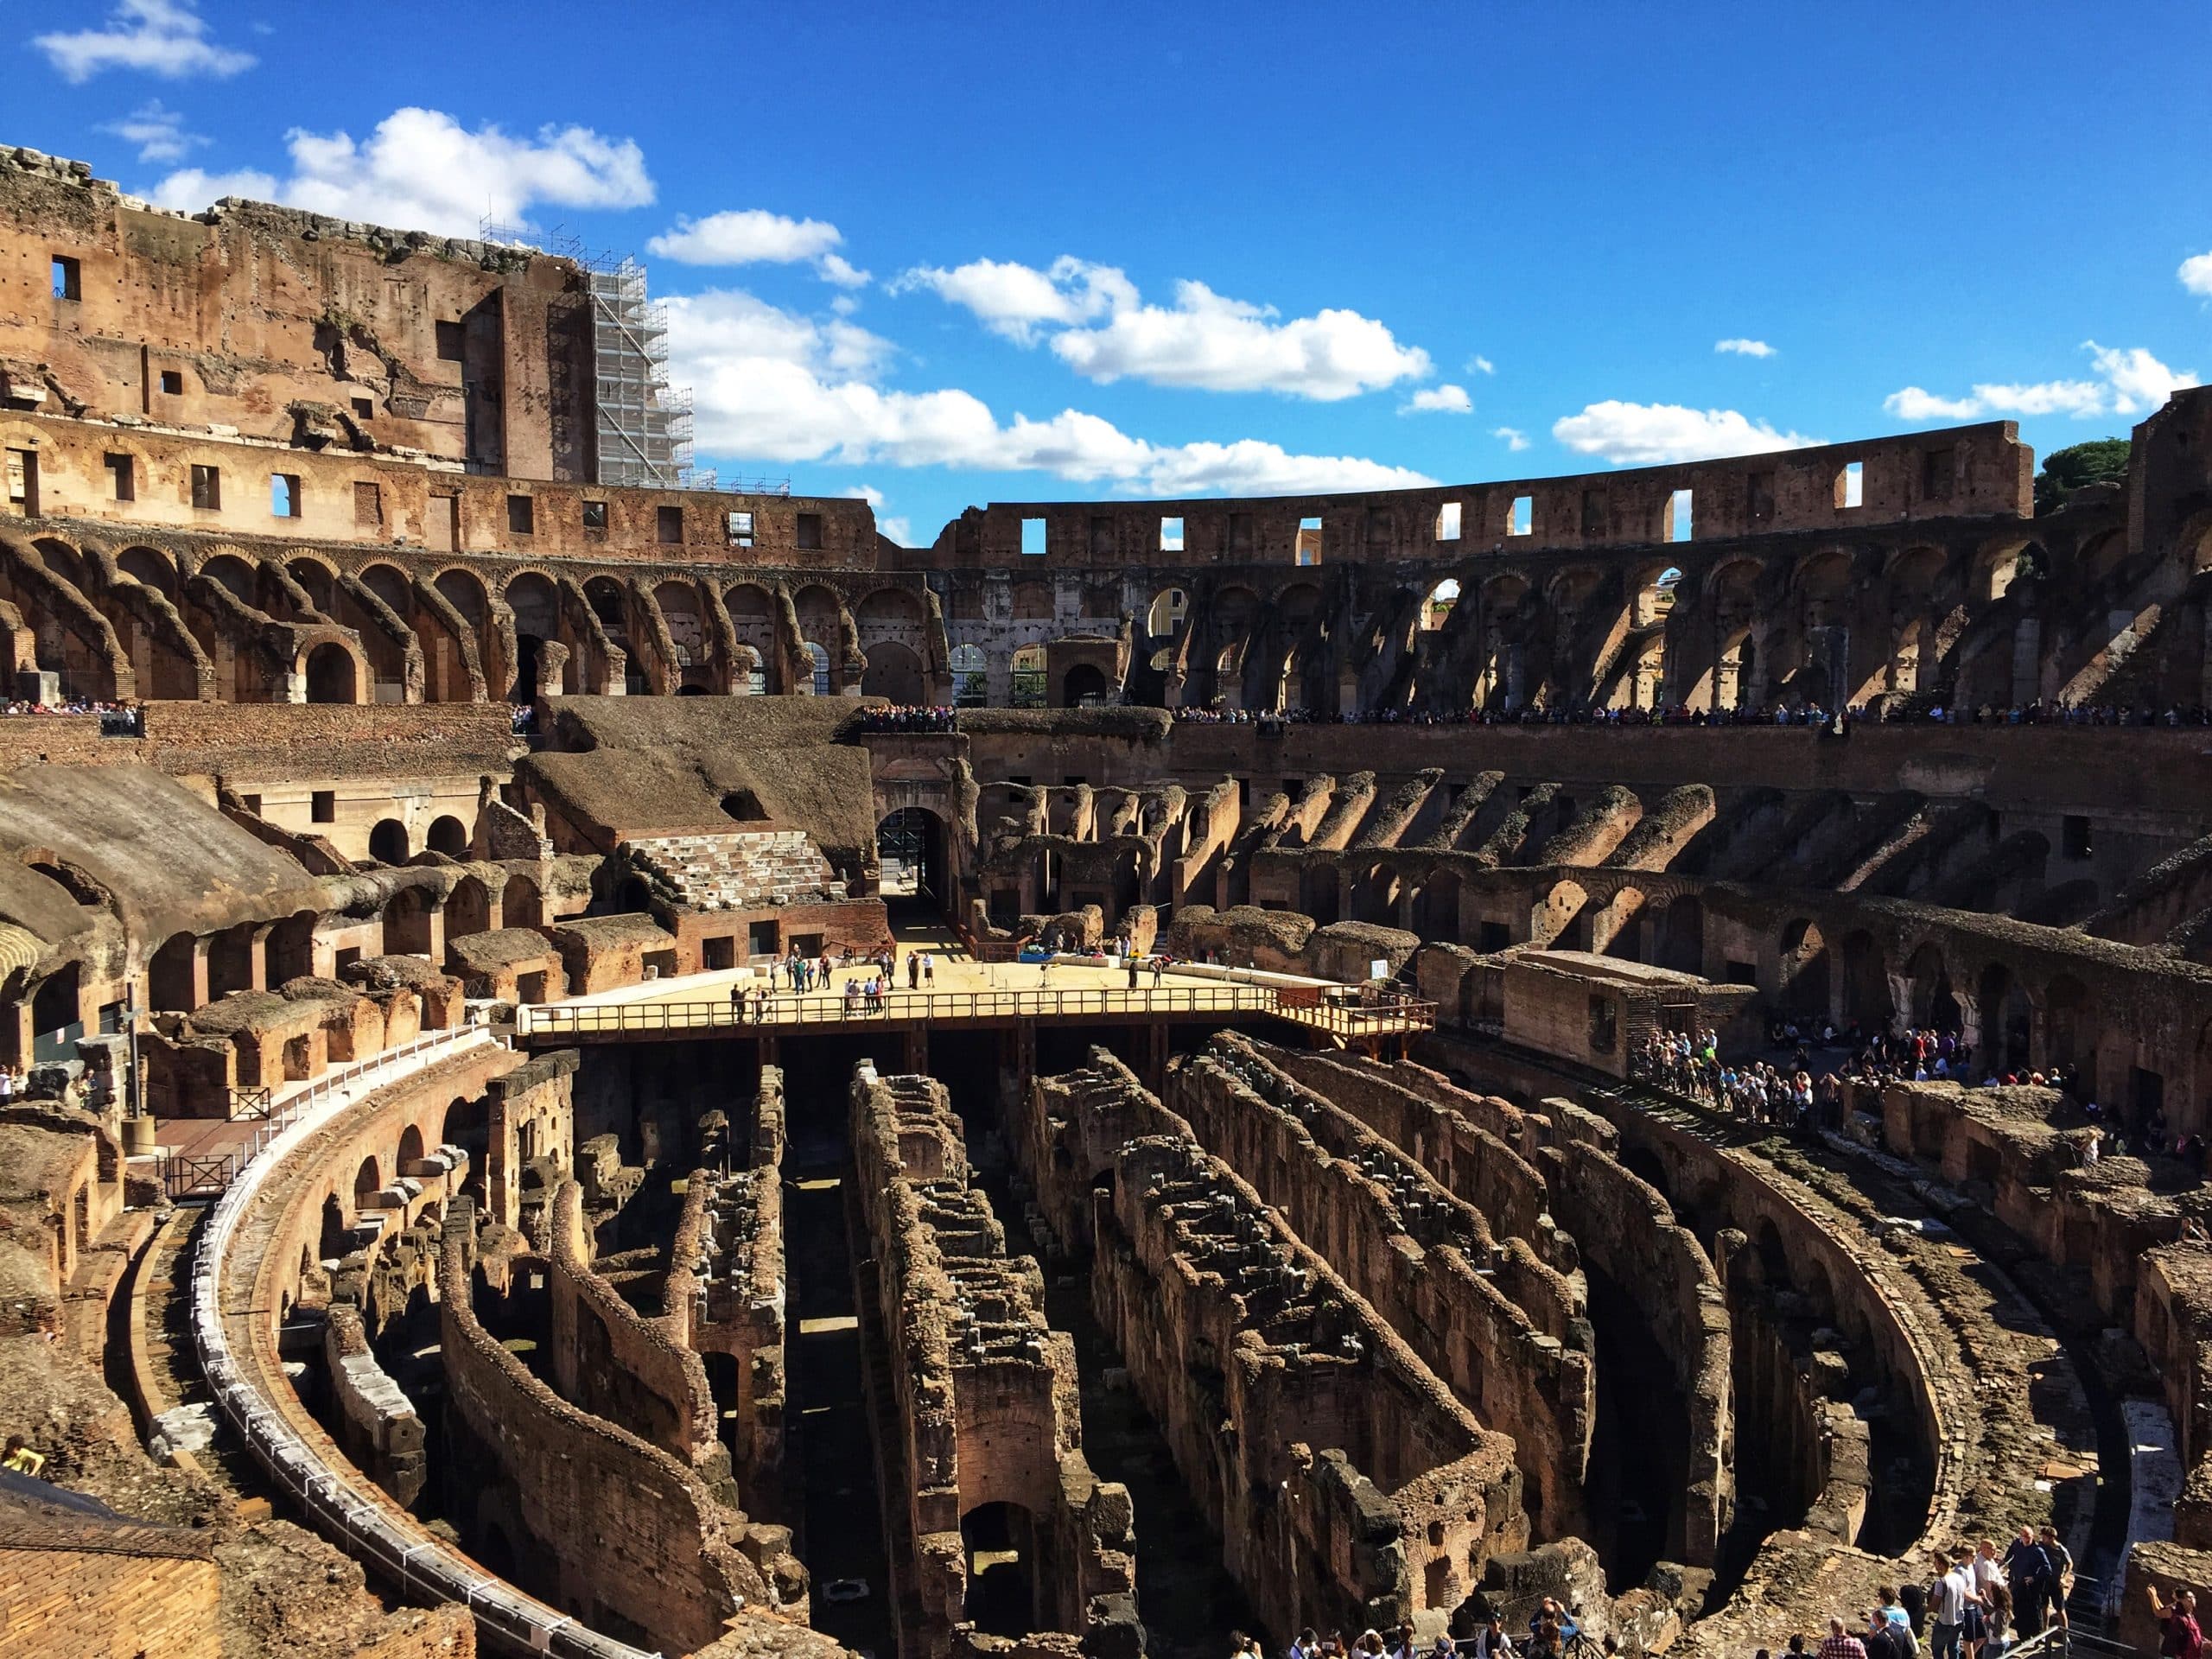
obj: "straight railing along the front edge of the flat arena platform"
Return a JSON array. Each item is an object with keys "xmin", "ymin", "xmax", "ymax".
[{"xmin": 515, "ymin": 984, "xmax": 1435, "ymax": 1038}]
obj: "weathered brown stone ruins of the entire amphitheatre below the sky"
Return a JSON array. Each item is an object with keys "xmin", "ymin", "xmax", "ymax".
[{"xmin": 0, "ymin": 139, "xmax": 2212, "ymax": 1659}]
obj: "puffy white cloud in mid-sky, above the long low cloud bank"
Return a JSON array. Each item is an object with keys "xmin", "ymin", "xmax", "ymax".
[{"xmin": 893, "ymin": 254, "xmax": 1433, "ymax": 403}]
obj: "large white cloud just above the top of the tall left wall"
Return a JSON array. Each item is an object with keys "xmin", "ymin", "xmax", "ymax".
[{"xmin": 149, "ymin": 108, "xmax": 652, "ymax": 237}]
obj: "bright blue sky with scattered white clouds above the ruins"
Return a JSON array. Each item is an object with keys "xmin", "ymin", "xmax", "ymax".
[{"xmin": 17, "ymin": 0, "xmax": 2212, "ymax": 542}]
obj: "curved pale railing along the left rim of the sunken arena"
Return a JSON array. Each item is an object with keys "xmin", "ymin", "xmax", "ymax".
[{"xmin": 193, "ymin": 1027, "xmax": 661, "ymax": 1659}]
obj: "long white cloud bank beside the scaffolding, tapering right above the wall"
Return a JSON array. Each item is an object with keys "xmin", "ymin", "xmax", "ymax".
[{"xmin": 668, "ymin": 289, "xmax": 1433, "ymax": 495}]
